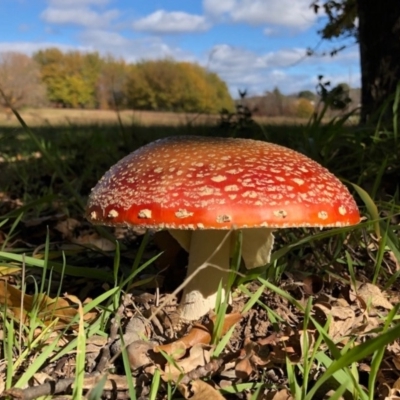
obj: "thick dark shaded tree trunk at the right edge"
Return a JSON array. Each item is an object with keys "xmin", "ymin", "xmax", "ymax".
[{"xmin": 357, "ymin": 0, "xmax": 400, "ymax": 123}]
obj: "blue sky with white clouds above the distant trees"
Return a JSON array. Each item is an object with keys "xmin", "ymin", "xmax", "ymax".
[{"xmin": 0, "ymin": 0, "xmax": 360, "ymax": 97}]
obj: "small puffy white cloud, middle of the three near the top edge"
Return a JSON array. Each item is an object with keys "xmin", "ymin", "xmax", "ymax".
[{"xmin": 133, "ymin": 10, "xmax": 209, "ymax": 33}]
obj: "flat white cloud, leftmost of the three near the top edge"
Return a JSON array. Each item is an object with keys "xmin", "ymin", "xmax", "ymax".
[{"xmin": 40, "ymin": 7, "xmax": 119, "ymax": 27}]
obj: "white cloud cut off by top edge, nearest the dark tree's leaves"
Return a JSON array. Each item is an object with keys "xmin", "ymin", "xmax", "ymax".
[{"xmin": 203, "ymin": 0, "xmax": 316, "ymax": 30}]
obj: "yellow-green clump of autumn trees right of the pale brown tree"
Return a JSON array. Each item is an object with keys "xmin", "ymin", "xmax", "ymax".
[{"xmin": 34, "ymin": 48, "xmax": 234, "ymax": 113}]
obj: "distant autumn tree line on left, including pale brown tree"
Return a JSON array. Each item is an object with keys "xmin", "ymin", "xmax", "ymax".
[{"xmin": 0, "ymin": 48, "xmax": 234, "ymax": 113}]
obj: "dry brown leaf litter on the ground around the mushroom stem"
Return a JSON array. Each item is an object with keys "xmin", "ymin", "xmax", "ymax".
[{"xmin": 0, "ymin": 164, "xmax": 400, "ymax": 400}]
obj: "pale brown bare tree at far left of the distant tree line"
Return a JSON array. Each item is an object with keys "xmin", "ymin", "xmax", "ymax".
[{"xmin": 0, "ymin": 52, "xmax": 46, "ymax": 114}]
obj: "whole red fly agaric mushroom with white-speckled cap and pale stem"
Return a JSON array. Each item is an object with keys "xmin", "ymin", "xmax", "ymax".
[{"xmin": 86, "ymin": 136, "xmax": 360, "ymax": 320}]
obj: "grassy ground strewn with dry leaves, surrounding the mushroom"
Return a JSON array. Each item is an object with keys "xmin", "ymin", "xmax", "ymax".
[{"xmin": 0, "ymin": 104, "xmax": 400, "ymax": 400}]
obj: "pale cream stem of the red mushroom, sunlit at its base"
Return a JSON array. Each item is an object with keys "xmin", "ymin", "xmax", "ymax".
[{"xmin": 170, "ymin": 229, "xmax": 231, "ymax": 321}]
